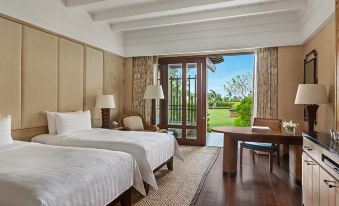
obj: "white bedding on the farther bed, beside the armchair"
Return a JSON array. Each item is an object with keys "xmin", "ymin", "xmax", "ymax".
[{"xmin": 32, "ymin": 128, "xmax": 183, "ymax": 189}]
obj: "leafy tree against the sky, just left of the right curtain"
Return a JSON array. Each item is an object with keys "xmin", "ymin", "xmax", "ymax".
[{"xmin": 224, "ymin": 72, "xmax": 253, "ymax": 100}]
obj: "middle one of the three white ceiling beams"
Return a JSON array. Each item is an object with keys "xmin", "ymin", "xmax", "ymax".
[{"xmin": 90, "ymin": 0, "xmax": 234, "ymax": 21}]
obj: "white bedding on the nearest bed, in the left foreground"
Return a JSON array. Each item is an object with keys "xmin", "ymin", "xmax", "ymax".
[{"xmin": 0, "ymin": 141, "xmax": 145, "ymax": 206}]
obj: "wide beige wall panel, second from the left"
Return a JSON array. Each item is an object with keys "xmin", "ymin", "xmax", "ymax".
[{"xmin": 22, "ymin": 26, "xmax": 58, "ymax": 128}]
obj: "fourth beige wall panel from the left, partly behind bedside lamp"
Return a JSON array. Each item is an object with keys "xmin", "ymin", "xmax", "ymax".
[{"xmin": 84, "ymin": 47, "xmax": 104, "ymax": 127}]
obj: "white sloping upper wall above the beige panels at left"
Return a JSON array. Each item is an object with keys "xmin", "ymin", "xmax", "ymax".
[{"xmin": 0, "ymin": 0, "xmax": 124, "ymax": 55}]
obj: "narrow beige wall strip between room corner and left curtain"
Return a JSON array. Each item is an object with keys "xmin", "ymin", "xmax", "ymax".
[{"xmin": 124, "ymin": 58, "xmax": 133, "ymax": 113}]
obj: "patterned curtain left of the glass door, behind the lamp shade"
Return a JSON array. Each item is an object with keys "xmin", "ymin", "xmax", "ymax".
[{"xmin": 132, "ymin": 57, "xmax": 156, "ymax": 122}]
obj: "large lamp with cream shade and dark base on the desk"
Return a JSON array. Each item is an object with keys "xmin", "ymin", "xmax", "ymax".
[{"xmin": 294, "ymin": 84, "xmax": 327, "ymax": 132}]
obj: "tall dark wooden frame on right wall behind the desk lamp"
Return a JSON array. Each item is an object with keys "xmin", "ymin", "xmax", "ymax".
[{"xmin": 304, "ymin": 49, "xmax": 318, "ymax": 121}]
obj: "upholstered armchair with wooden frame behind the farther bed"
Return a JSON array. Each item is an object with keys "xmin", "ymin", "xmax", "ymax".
[{"xmin": 118, "ymin": 113, "xmax": 159, "ymax": 132}]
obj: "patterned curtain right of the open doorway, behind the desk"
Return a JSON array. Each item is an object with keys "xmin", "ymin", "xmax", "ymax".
[{"xmin": 253, "ymin": 47, "xmax": 278, "ymax": 119}]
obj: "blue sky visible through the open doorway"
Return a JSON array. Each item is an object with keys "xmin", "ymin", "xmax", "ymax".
[{"xmin": 208, "ymin": 54, "xmax": 254, "ymax": 97}]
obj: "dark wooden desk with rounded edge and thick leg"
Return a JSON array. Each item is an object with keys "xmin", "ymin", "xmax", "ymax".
[{"xmin": 212, "ymin": 126, "xmax": 303, "ymax": 176}]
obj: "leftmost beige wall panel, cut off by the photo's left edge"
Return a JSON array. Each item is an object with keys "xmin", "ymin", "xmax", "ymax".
[{"xmin": 0, "ymin": 18, "xmax": 22, "ymax": 129}]
